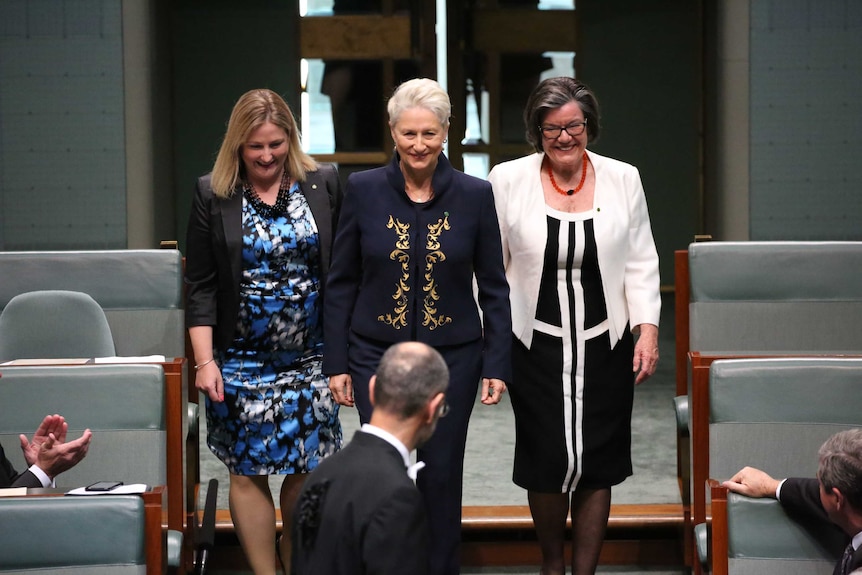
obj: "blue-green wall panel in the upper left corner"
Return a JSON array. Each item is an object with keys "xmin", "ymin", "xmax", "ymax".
[{"xmin": 0, "ymin": 0, "xmax": 126, "ymax": 250}]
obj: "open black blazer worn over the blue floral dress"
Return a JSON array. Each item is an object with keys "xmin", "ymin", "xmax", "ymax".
[{"xmin": 185, "ymin": 164, "xmax": 341, "ymax": 350}]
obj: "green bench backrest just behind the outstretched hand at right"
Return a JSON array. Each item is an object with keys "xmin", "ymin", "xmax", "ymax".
[{"xmin": 709, "ymin": 358, "xmax": 862, "ymax": 480}]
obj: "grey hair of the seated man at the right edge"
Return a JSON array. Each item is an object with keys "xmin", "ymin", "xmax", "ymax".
[{"xmin": 817, "ymin": 429, "xmax": 862, "ymax": 512}]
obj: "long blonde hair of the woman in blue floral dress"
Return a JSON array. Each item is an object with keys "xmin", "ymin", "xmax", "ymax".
[{"xmin": 212, "ymin": 89, "xmax": 317, "ymax": 198}]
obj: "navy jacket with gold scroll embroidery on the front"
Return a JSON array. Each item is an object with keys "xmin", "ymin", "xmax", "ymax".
[{"xmin": 323, "ymin": 154, "xmax": 512, "ymax": 381}]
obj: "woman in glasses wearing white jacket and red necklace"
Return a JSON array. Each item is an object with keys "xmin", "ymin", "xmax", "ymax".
[{"xmin": 488, "ymin": 77, "xmax": 661, "ymax": 575}]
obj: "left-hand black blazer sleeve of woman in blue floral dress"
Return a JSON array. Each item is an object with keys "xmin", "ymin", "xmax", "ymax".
[{"xmin": 185, "ymin": 177, "xmax": 218, "ymax": 327}]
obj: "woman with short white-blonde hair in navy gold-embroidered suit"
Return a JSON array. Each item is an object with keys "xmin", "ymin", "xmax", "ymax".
[{"xmin": 323, "ymin": 78, "xmax": 512, "ymax": 575}]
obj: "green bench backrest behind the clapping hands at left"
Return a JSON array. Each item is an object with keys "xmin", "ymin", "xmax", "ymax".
[{"xmin": 0, "ymin": 364, "xmax": 167, "ymax": 500}]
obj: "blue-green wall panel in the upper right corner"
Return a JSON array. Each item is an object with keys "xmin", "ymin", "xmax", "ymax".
[{"xmin": 749, "ymin": 0, "xmax": 862, "ymax": 240}]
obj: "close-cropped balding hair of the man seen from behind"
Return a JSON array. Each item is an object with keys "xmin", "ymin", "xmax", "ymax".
[{"xmin": 374, "ymin": 341, "xmax": 449, "ymax": 419}]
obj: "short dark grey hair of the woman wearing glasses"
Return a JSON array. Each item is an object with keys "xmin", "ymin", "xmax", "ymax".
[{"xmin": 524, "ymin": 76, "xmax": 601, "ymax": 152}]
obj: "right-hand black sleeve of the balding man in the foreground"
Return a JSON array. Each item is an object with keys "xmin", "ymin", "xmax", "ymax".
[{"xmin": 362, "ymin": 486, "xmax": 428, "ymax": 575}]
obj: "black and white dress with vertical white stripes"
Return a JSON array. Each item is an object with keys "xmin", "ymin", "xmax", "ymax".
[{"xmin": 509, "ymin": 207, "xmax": 634, "ymax": 493}]
